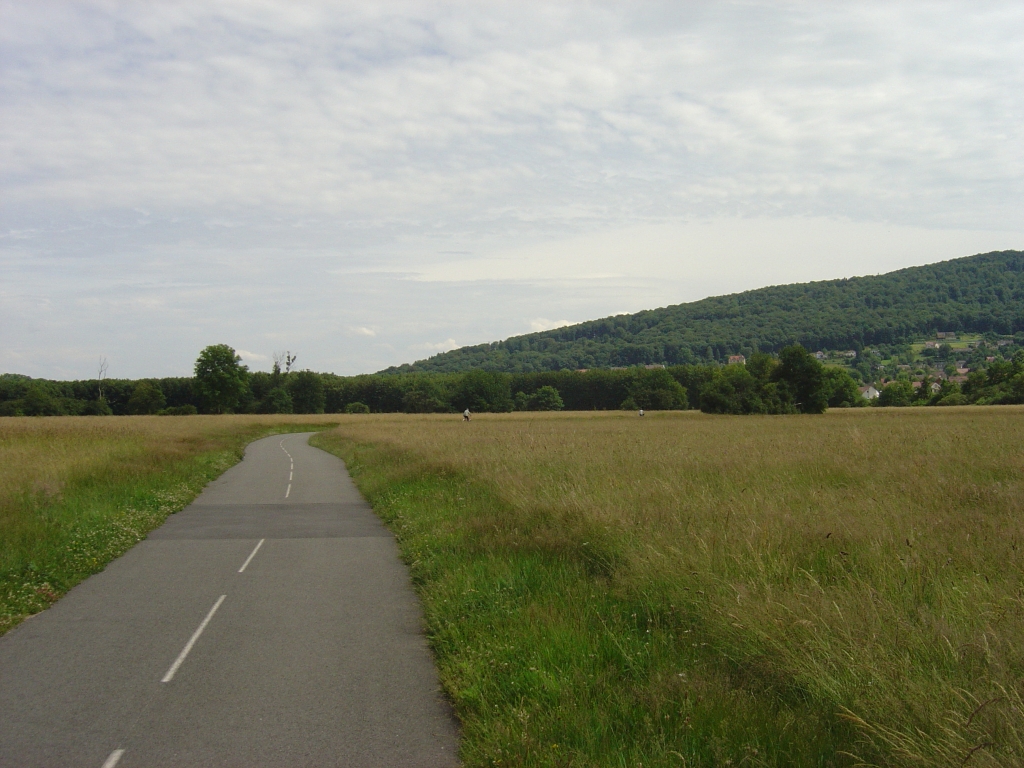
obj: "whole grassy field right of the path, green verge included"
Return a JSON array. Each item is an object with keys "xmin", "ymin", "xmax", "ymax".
[{"xmin": 313, "ymin": 407, "xmax": 1024, "ymax": 768}]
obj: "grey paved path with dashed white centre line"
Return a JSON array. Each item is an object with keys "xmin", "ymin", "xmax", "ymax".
[{"xmin": 0, "ymin": 434, "xmax": 458, "ymax": 768}]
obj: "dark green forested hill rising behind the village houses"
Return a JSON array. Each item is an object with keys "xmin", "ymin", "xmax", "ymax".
[{"xmin": 381, "ymin": 251, "xmax": 1024, "ymax": 373}]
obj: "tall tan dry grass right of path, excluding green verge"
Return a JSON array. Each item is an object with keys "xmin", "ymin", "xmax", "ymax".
[{"xmin": 318, "ymin": 408, "xmax": 1024, "ymax": 767}]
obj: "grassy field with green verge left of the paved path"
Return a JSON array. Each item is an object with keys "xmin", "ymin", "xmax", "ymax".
[{"xmin": 0, "ymin": 416, "xmax": 338, "ymax": 634}]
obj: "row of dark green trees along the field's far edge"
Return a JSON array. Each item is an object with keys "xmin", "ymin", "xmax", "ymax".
[{"xmin": 8, "ymin": 344, "xmax": 1024, "ymax": 416}]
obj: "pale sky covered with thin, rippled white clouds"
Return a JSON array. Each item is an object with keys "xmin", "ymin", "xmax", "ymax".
[{"xmin": 0, "ymin": 0, "xmax": 1024, "ymax": 379}]
